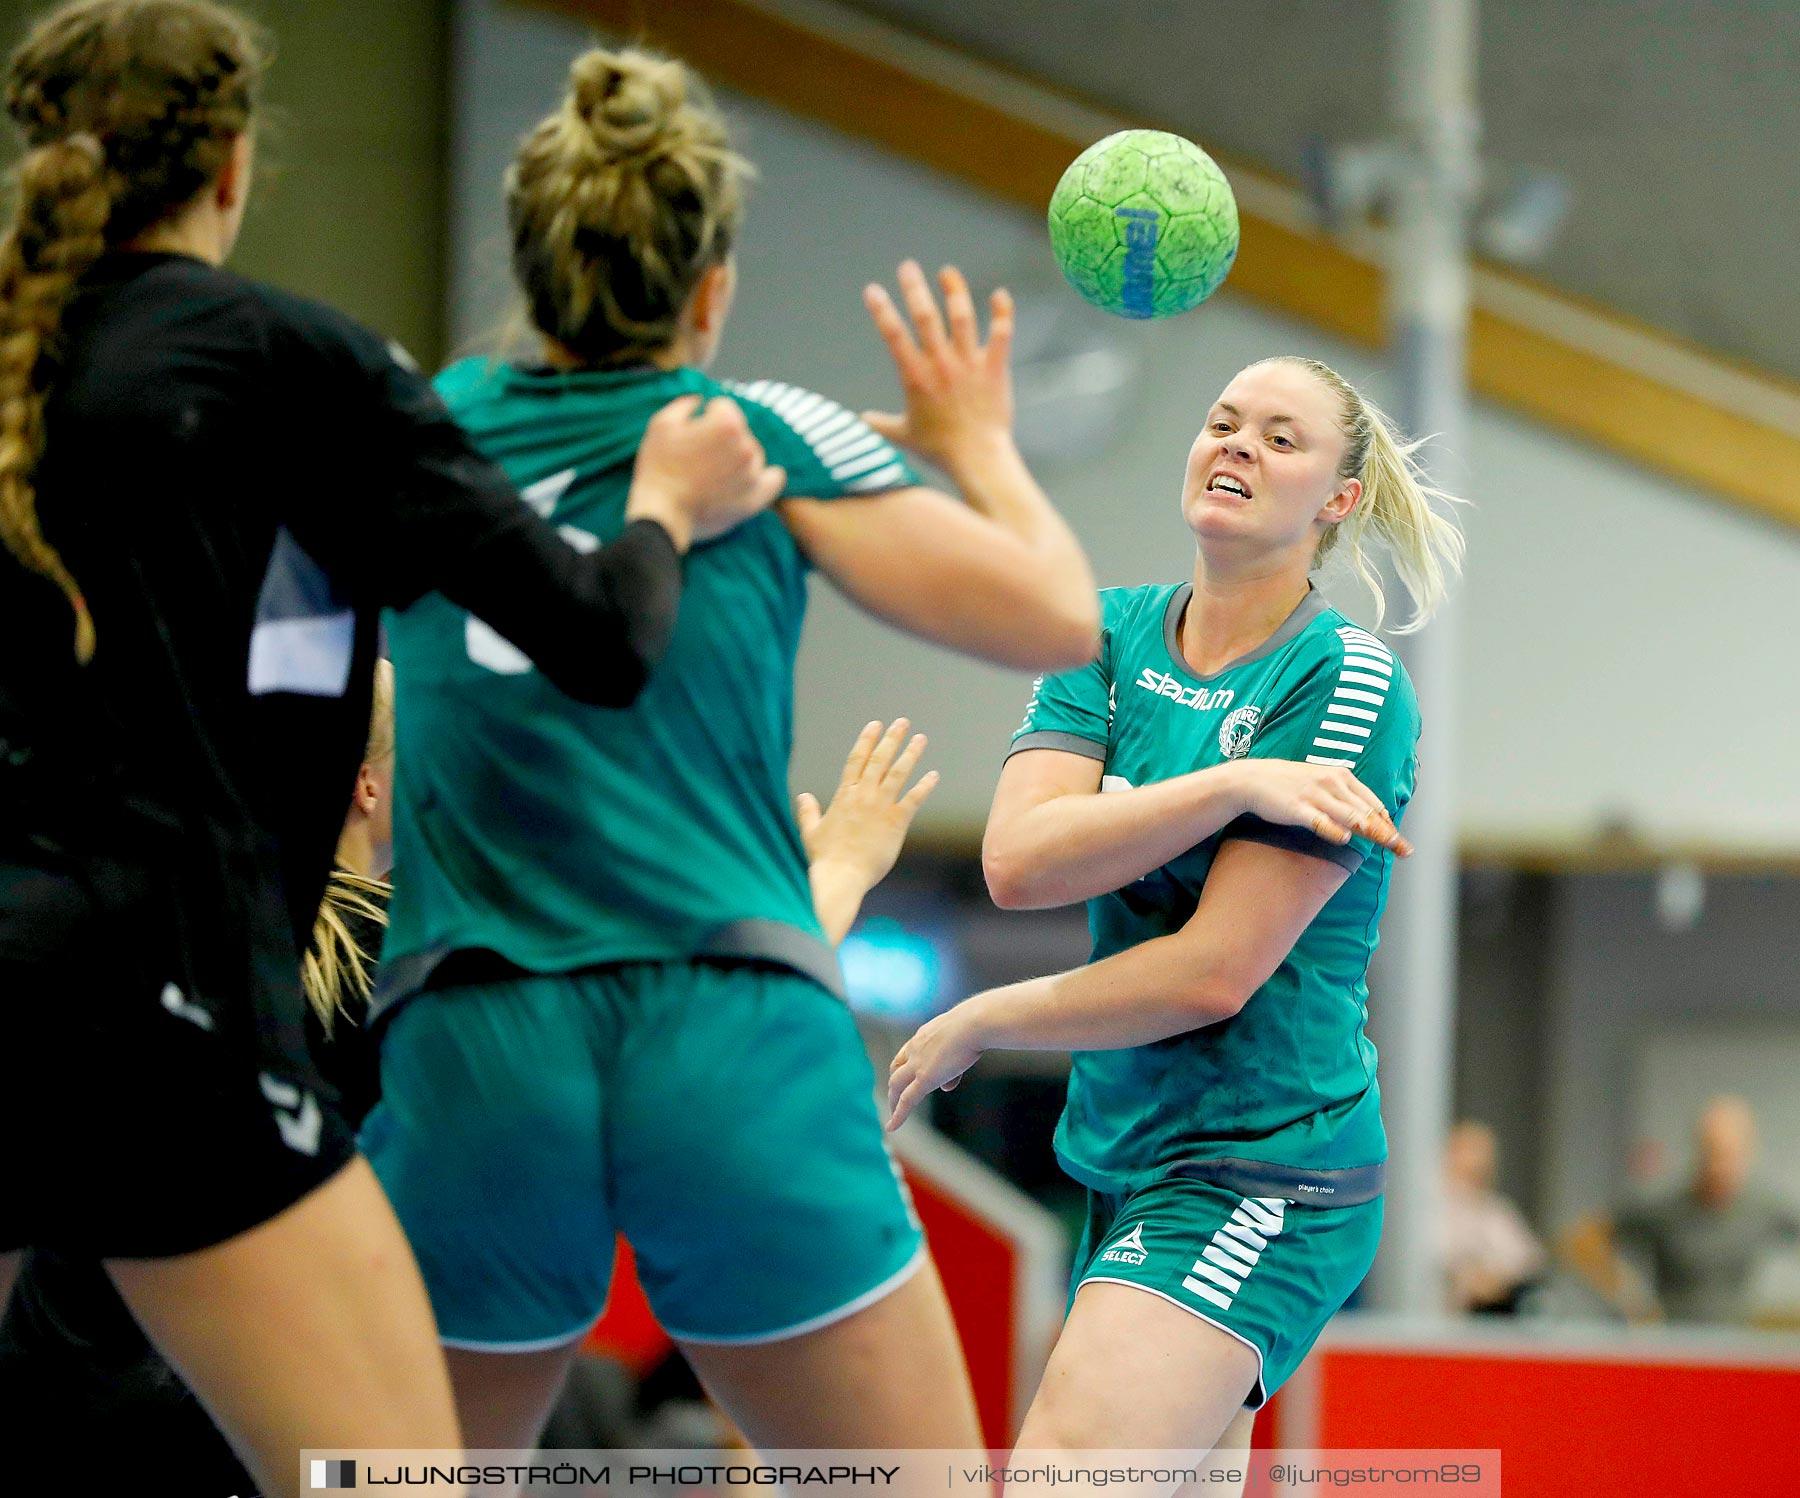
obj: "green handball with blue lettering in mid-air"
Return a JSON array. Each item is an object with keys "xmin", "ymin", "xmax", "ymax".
[{"xmin": 1049, "ymin": 130, "xmax": 1238, "ymax": 317}]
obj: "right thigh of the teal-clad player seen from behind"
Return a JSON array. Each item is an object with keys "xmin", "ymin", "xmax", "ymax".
[{"xmin": 682, "ymin": 1262, "xmax": 981, "ymax": 1449}]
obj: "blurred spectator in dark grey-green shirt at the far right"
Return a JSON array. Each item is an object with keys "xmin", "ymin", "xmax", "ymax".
[{"xmin": 1613, "ymin": 1096, "xmax": 1800, "ymax": 1325}]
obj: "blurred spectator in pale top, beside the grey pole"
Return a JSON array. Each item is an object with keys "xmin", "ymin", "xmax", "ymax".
[{"xmin": 1438, "ymin": 1122, "xmax": 1546, "ymax": 1316}]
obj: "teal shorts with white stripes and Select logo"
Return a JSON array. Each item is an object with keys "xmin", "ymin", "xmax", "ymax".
[{"xmin": 1069, "ymin": 1178, "xmax": 1381, "ymax": 1410}]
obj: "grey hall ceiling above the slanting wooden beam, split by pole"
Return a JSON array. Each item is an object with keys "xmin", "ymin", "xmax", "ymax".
[{"xmin": 850, "ymin": 0, "xmax": 1800, "ymax": 392}]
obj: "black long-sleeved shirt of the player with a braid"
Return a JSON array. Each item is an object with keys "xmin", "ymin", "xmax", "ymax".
[{"xmin": 0, "ymin": 254, "xmax": 680, "ymax": 1008}]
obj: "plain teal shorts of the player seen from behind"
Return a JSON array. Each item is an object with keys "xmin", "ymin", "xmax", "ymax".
[{"xmin": 362, "ymin": 963, "xmax": 923, "ymax": 1352}]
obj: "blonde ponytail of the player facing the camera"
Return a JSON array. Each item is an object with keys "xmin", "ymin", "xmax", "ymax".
[{"xmin": 1280, "ymin": 355, "xmax": 1465, "ymax": 634}]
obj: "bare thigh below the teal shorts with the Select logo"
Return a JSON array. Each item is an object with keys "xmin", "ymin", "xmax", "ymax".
[{"xmin": 1019, "ymin": 1282, "xmax": 1258, "ymax": 1451}]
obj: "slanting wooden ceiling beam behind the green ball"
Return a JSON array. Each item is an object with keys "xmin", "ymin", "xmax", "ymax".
[{"xmin": 520, "ymin": 0, "xmax": 1800, "ymax": 528}]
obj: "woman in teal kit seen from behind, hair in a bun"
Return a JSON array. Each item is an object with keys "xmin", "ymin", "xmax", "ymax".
[{"xmin": 364, "ymin": 50, "xmax": 1098, "ymax": 1448}]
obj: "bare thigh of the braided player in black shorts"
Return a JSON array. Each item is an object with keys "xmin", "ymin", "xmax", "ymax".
[{"xmin": 106, "ymin": 1160, "xmax": 461, "ymax": 1493}]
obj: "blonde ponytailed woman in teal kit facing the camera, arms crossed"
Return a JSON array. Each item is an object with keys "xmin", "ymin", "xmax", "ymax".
[{"xmin": 889, "ymin": 358, "xmax": 1462, "ymax": 1491}]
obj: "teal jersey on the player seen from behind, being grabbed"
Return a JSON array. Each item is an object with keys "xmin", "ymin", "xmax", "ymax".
[{"xmin": 378, "ymin": 360, "xmax": 918, "ymax": 1008}]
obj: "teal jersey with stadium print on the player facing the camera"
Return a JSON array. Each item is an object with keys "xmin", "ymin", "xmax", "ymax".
[{"xmin": 1012, "ymin": 583, "xmax": 1418, "ymax": 1192}]
